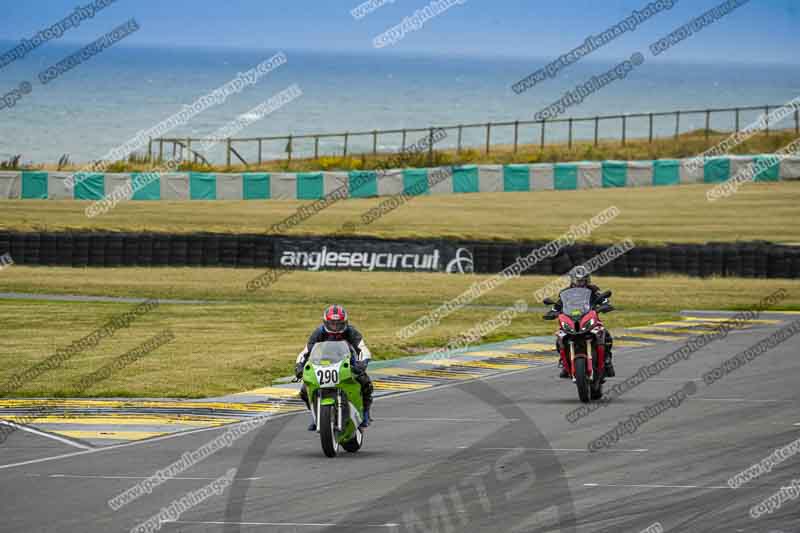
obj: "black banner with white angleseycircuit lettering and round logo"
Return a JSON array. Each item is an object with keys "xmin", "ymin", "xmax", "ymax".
[{"xmin": 273, "ymin": 238, "xmax": 473, "ymax": 273}]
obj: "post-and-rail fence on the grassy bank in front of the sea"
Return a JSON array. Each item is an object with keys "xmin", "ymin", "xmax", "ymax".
[{"xmin": 152, "ymin": 101, "xmax": 800, "ymax": 166}]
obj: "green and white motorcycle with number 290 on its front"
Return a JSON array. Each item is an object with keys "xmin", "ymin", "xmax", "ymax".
[{"xmin": 303, "ymin": 341, "xmax": 364, "ymax": 457}]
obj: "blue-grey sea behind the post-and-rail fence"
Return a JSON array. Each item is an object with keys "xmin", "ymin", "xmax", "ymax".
[{"xmin": 0, "ymin": 42, "xmax": 800, "ymax": 164}]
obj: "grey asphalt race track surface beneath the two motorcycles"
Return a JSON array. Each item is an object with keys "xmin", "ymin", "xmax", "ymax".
[{"xmin": 0, "ymin": 316, "xmax": 800, "ymax": 533}]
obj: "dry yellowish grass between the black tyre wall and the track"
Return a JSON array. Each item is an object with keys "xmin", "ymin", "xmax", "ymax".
[{"xmin": 0, "ymin": 266, "xmax": 800, "ymax": 397}]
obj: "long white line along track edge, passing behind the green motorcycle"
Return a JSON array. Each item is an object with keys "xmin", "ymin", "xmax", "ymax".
[{"xmin": 0, "ymin": 363, "xmax": 556, "ymax": 470}]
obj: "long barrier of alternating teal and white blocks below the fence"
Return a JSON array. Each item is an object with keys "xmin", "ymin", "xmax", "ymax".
[{"xmin": 0, "ymin": 155, "xmax": 800, "ymax": 201}]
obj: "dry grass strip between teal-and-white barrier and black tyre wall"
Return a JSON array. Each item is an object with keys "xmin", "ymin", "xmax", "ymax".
[{"xmin": 0, "ymin": 182, "xmax": 800, "ymax": 243}]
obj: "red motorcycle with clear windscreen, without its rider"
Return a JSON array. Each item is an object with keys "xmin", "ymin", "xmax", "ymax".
[{"xmin": 544, "ymin": 287, "xmax": 614, "ymax": 403}]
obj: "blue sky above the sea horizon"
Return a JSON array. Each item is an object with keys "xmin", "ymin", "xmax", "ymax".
[{"xmin": 0, "ymin": 0, "xmax": 800, "ymax": 64}]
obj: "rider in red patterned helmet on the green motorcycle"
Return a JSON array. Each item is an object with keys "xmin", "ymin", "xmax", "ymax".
[{"xmin": 294, "ymin": 305, "xmax": 373, "ymax": 431}]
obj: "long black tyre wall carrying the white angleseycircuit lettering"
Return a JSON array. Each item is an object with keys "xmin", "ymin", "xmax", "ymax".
[{"xmin": 0, "ymin": 232, "xmax": 800, "ymax": 278}]
